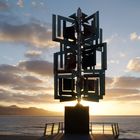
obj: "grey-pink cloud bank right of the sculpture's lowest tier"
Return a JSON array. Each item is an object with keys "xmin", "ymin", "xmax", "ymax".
[{"xmin": 104, "ymin": 76, "xmax": 140, "ymax": 102}]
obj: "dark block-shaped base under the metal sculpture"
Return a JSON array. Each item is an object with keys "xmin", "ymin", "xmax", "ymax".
[{"xmin": 64, "ymin": 104, "xmax": 89, "ymax": 134}]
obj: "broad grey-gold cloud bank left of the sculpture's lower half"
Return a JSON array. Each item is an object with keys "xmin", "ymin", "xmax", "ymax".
[{"xmin": 0, "ymin": 60, "xmax": 53, "ymax": 94}]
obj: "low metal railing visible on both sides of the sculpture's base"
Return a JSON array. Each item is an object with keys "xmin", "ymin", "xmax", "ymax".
[{"xmin": 44, "ymin": 122, "xmax": 119, "ymax": 139}]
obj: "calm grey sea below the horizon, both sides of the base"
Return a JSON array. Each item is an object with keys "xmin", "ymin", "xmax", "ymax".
[{"xmin": 0, "ymin": 116, "xmax": 140, "ymax": 139}]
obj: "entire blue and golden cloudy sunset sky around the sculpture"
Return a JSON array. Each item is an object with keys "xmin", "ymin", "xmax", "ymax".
[{"xmin": 0, "ymin": 0, "xmax": 140, "ymax": 115}]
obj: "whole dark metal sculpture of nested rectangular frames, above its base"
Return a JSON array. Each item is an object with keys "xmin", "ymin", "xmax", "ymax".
[{"xmin": 52, "ymin": 8, "xmax": 107, "ymax": 102}]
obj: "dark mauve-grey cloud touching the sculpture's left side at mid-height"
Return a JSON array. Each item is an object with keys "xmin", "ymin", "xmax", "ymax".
[{"xmin": 18, "ymin": 60, "xmax": 53, "ymax": 76}]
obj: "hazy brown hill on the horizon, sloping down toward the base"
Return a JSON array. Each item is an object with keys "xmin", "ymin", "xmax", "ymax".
[{"xmin": 0, "ymin": 105, "xmax": 62, "ymax": 116}]
